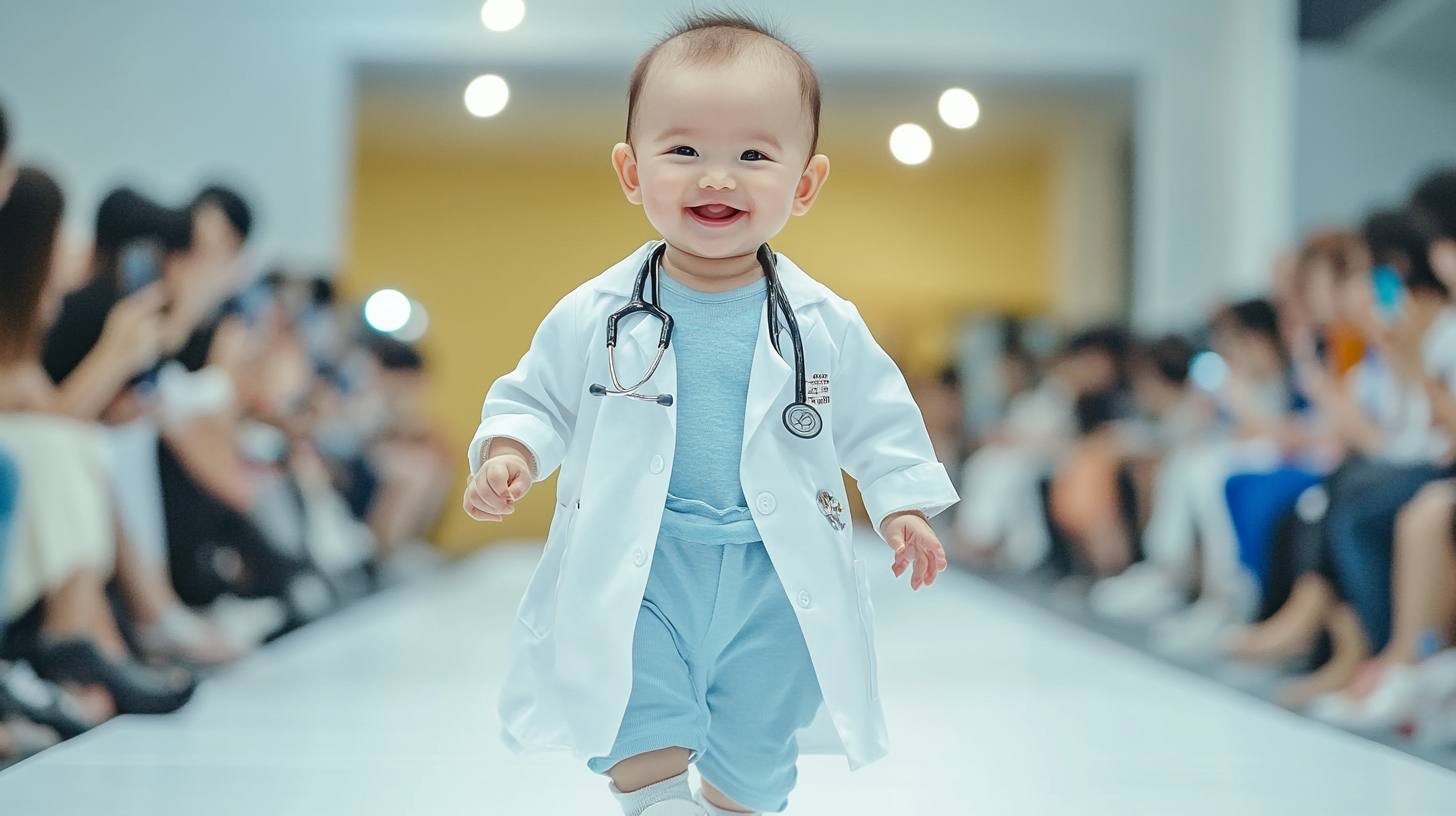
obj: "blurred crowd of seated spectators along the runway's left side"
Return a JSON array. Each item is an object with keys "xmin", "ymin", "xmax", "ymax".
[{"xmin": 0, "ymin": 103, "xmax": 453, "ymax": 761}]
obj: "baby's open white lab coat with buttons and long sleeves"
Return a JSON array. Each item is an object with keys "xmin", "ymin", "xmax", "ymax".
[{"xmin": 470, "ymin": 245, "xmax": 957, "ymax": 768}]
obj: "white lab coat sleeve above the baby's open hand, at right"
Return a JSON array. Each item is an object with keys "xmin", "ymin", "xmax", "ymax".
[{"xmin": 830, "ymin": 306, "xmax": 960, "ymax": 533}]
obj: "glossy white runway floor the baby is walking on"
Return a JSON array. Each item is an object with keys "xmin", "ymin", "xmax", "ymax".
[{"xmin": 0, "ymin": 542, "xmax": 1456, "ymax": 816}]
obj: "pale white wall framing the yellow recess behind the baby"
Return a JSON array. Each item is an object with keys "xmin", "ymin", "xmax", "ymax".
[{"xmin": 0, "ymin": 0, "xmax": 1296, "ymax": 328}]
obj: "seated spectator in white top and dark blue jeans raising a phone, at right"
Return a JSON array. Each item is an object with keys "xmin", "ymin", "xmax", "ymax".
[{"xmin": 1229, "ymin": 213, "xmax": 1456, "ymax": 720}]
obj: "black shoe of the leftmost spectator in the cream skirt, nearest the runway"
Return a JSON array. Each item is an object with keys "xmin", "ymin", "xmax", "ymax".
[{"xmin": 33, "ymin": 638, "xmax": 197, "ymax": 714}]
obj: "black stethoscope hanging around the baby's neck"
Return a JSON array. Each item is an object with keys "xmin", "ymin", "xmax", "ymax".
[{"xmin": 588, "ymin": 242, "xmax": 824, "ymax": 439}]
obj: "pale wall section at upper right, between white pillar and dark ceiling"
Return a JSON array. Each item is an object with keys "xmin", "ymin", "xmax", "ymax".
[{"xmin": 1294, "ymin": 48, "xmax": 1456, "ymax": 230}]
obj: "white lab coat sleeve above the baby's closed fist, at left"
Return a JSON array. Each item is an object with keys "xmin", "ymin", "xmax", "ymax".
[{"xmin": 469, "ymin": 290, "xmax": 587, "ymax": 481}]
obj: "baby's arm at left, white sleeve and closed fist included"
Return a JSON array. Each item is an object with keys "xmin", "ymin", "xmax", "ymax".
[{"xmin": 464, "ymin": 290, "xmax": 587, "ymax": 522}]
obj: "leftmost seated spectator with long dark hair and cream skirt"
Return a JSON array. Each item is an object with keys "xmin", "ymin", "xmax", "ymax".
[{"xmin": 0, "ymin": 169, "xmax": 195, "ymax": 718}]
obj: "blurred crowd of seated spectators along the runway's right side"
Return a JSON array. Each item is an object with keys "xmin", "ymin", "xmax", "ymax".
[{"xmin": 920, "ymin": 169, "xmax": 1456, "ymax": 746}]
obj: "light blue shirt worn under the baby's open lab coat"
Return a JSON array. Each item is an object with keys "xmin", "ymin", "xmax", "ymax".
[{"xmin": 662, "ymin": 274, "xmax": 767, "ymax": 544}]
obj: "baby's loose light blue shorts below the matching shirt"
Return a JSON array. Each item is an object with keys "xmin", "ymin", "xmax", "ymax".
[{"xmin": 587, "ymin": 506, "xmax": 823, "ymax": 813}]
